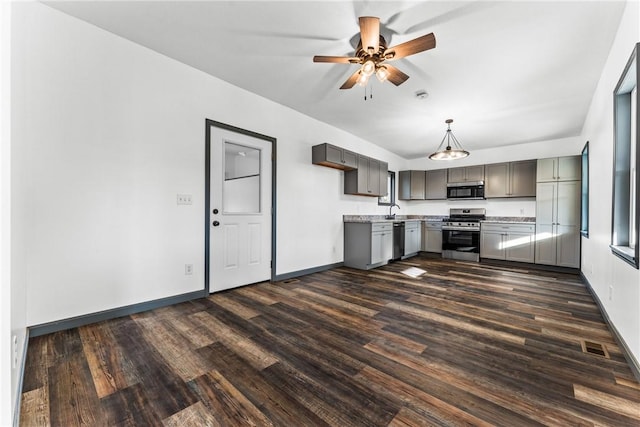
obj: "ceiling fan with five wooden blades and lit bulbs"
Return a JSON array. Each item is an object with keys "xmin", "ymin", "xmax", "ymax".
[{"xmin": 313, "ymin": 16, "xmax": 436, "ymax": 89}]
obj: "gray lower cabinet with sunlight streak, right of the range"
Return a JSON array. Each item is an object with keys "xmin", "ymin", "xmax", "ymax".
[{"xmin": 480, "ymin": 223, "xmax": 536, "ymax": 263}]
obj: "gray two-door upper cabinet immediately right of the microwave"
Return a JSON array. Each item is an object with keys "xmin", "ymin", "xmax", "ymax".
[{"xmin": 485, "ymin": 160, "xmax": 537, "ymax": 198}]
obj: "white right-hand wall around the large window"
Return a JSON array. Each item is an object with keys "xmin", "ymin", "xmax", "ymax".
[{"xmin": 582, "ymin": 1, "xmax": 640, "ymax": 368}]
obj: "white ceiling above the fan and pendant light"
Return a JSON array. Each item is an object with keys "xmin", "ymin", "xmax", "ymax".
[{"xmin": 46, "ymin": 0, "xmax": 624, "ymax": 159}]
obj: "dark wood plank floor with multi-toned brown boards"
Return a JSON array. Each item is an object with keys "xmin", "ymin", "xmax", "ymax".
[{"xmin": 20, "ymin": 257, "xmax": 640, "ymax": 426}]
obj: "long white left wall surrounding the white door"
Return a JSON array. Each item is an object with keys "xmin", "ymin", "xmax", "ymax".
[{"xmin": 12, "ymin": 3, "xmax": 405, "ymax": 325}]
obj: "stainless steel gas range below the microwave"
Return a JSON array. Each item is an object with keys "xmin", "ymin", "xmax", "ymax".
[{"xmin": 442, "ymin": 208, "xmax": 486, "ymax": 261}]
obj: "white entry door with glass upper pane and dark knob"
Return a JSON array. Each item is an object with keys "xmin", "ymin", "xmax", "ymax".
[{"xmin": 209, "ymin": 126, "xmax": 272, "ymax": 292}]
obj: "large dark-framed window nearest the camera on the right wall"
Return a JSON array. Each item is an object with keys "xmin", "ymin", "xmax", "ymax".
[{"xmin": 611, "ymin": 43, "xmax": 640, "ymax": 268}]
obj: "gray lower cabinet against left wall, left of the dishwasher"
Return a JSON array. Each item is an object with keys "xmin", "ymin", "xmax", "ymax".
[{"xmin": 344, "ymin": 222, "xmax": 393, "ymax": 270}]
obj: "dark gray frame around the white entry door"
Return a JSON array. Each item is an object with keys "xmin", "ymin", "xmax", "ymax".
[{"xmin": 204, "ymin": 119, "xmax": 277, "ymax": 295}]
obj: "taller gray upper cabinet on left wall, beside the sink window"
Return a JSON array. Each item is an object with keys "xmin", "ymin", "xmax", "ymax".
[{"xmin": 344, "ymin": 154, "xmax": 388, "ymax": 197}]
